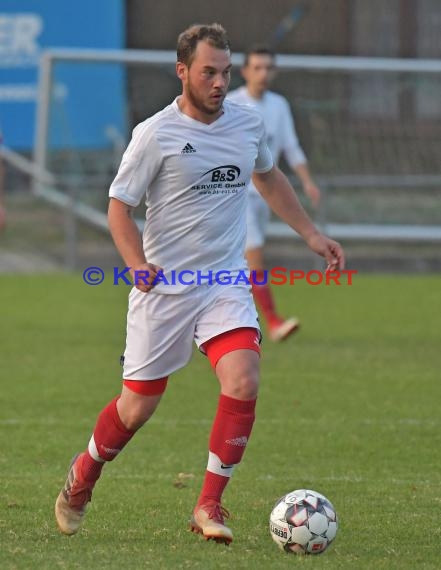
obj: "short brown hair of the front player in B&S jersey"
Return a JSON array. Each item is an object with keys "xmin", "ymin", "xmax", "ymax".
[{"xmin": 176, "ymin": 24, "xmax": 231, "ymax": 67}]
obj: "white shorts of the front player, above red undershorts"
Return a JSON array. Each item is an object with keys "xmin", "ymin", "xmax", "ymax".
[{"xmin": 123, "ymin": 284, "xmax": 260, "ymax": 380}]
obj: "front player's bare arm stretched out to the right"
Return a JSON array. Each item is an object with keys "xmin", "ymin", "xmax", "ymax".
[{"xmin": 253, "ymin": 166, "xmax": 345, "ymax": 270}]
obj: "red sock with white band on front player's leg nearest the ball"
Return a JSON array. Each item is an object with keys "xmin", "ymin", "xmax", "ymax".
[{"xmin": 198, "ymin": 394, "xmax": 256, "ymax": 505}]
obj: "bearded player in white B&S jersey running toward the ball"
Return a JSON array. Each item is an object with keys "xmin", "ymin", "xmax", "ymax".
[{"xmin": 55, "ymin": 24, "xmax": 344, "ymax": 543}]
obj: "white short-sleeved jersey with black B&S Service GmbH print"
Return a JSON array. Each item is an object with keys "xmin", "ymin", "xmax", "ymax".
[{"xmin": 109, "ymin": 100, "xmax": 273, "ymax": 294}]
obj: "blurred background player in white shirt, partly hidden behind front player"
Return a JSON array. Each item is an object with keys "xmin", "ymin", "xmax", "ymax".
[{"xmin": 227, "ymin": 45, "xmax": 320, "ymax": 342}]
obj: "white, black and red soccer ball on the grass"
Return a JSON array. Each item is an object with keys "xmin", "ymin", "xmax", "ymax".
[{"xmin": 270, "ymin": 489, "xmax": 338, "ymax": 554}]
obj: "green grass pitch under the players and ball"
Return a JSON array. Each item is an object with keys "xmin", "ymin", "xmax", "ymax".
[{"xmin": 0, "ymin": 275, "xmax": 441, "ymax": 570}]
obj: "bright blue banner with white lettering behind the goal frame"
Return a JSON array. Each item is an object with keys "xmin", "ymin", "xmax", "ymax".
[{"xmin": 0, "ymin": 0, "xmax": 126, "ymax": 150}]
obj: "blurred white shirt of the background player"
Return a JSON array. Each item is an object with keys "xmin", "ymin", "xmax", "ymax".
[{"xmin": 227, "ymin": 86, "xmax": 306, "ymax": 192}]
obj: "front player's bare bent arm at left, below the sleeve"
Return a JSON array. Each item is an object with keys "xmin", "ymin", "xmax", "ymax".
[{"xmin": 108, "ymin": 198, "xmax": 161, "ymax": 293}]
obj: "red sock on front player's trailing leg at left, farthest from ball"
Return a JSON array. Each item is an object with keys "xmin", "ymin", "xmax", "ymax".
[{"xmin": 80, "ymin": 396, "xmax": 135, "ymax": 483}]
